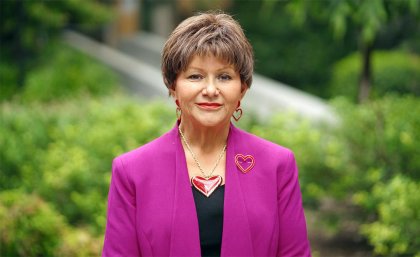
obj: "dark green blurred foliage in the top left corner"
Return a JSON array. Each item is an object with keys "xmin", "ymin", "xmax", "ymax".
[{"xmin": 0, "ymin": 0, "xmax": 114, "ymax": 90}]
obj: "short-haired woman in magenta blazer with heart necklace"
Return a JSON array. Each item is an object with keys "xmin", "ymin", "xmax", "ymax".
[{"xmin": 103, "ymin": 13, "xmax": 310, "ymax": 256}]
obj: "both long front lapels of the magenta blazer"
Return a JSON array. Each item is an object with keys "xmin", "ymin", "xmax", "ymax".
[{"xmin": 170, "ymin": 124, "xmax": 253, "ymax": 256}]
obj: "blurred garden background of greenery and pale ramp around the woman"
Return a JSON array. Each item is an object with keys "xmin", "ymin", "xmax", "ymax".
[{"xmin": 0, "ymin": 0, "xmax": 420, "ymax": 256}]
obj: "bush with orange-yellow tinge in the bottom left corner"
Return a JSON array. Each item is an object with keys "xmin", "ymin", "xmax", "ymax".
[{"xmin": 0, "ymin": 190, "xmax": 102, "ymax": 257}]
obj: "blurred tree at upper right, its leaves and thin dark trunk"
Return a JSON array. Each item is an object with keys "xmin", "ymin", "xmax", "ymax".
[{"xmin": 280, "ymin": 0, "xmax": 420, "ymax": 102}]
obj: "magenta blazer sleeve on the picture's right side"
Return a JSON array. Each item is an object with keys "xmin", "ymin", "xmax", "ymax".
[{"xmin": 277, "ymin": 151, "xmax": 311, "ymax": 257}]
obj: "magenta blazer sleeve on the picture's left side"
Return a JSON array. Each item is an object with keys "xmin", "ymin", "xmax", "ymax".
[{"xmin": 102, "ymin": 157, "xmax": 140, "ymax": 257}]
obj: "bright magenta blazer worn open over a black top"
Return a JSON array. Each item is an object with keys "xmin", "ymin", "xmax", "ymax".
[{"xmin": 102, "ymin": 125, "xmax": 311, "ymax": 257}]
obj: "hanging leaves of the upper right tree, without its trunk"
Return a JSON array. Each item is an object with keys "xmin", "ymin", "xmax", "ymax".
[{"xmin": 282, "ymin": 0, "xmax": 420, "ymax": 45}]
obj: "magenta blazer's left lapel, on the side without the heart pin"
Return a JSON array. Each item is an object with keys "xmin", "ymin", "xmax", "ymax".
[{"xmin": 169, "ymin": 125, "xmax": 201, "ymax": 256}]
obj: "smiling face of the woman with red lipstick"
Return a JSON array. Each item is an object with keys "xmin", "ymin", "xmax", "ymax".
[{"xmin": 171, "ymin": 55, "xmax": 247, "ymax": 127}]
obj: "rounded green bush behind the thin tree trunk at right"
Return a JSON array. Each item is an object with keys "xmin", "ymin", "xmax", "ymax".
[{"xmin": 330, "ymin": 51, "xmax": 420, "ymax": 100}]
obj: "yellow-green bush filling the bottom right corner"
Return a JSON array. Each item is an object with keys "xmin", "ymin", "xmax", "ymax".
[{"xmin": 360, "ymin": 175, "xmax": 420, "ymax": 256}]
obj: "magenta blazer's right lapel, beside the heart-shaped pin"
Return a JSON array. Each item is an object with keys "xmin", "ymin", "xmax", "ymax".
[{"xmin": 221, "ymin": 125, "xmax": 253, "ymax": 256}]
